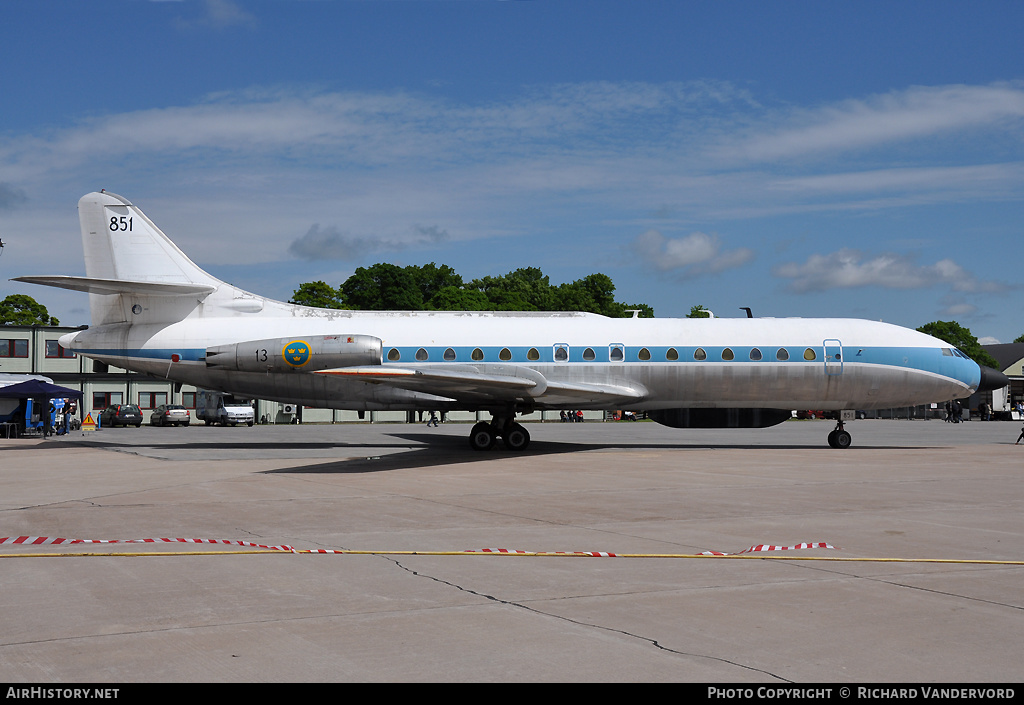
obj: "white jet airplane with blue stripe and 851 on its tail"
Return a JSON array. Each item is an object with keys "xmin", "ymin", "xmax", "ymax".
[{"xmin": 13, "ymin": 191, "xmax": 1009, "ymax": 451}]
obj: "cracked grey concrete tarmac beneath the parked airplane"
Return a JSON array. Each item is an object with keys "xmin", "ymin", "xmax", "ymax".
[{"xmin": 0, "ymin": 420, "xmax": 1024, "ymax": 685}]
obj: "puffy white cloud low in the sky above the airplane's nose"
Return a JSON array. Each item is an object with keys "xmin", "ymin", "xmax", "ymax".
[{"xmin": 772, "ymin": 249, "xmax": 1011, "ymax": 293}]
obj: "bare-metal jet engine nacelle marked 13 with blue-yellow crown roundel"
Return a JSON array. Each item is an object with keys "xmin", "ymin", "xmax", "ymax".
[{"xmin": 206, "ymin": 335, "xmax": 384, "ymax": 372}]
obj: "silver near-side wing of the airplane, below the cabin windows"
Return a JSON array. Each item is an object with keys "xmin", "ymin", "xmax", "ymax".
[{"xmin": 315, "ymin": 366, "xmax": 646, "ymax": 406}]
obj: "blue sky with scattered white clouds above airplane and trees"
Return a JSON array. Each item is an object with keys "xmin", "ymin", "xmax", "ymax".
[{"xmin": 0, "ymin": 0, "xmax": 1024, "ymax": 342}]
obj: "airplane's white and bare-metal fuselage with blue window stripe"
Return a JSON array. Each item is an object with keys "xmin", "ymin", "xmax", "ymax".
[{"xmin": 63, "ymin": 301, "xmax": 979, "ymax": 410}]
